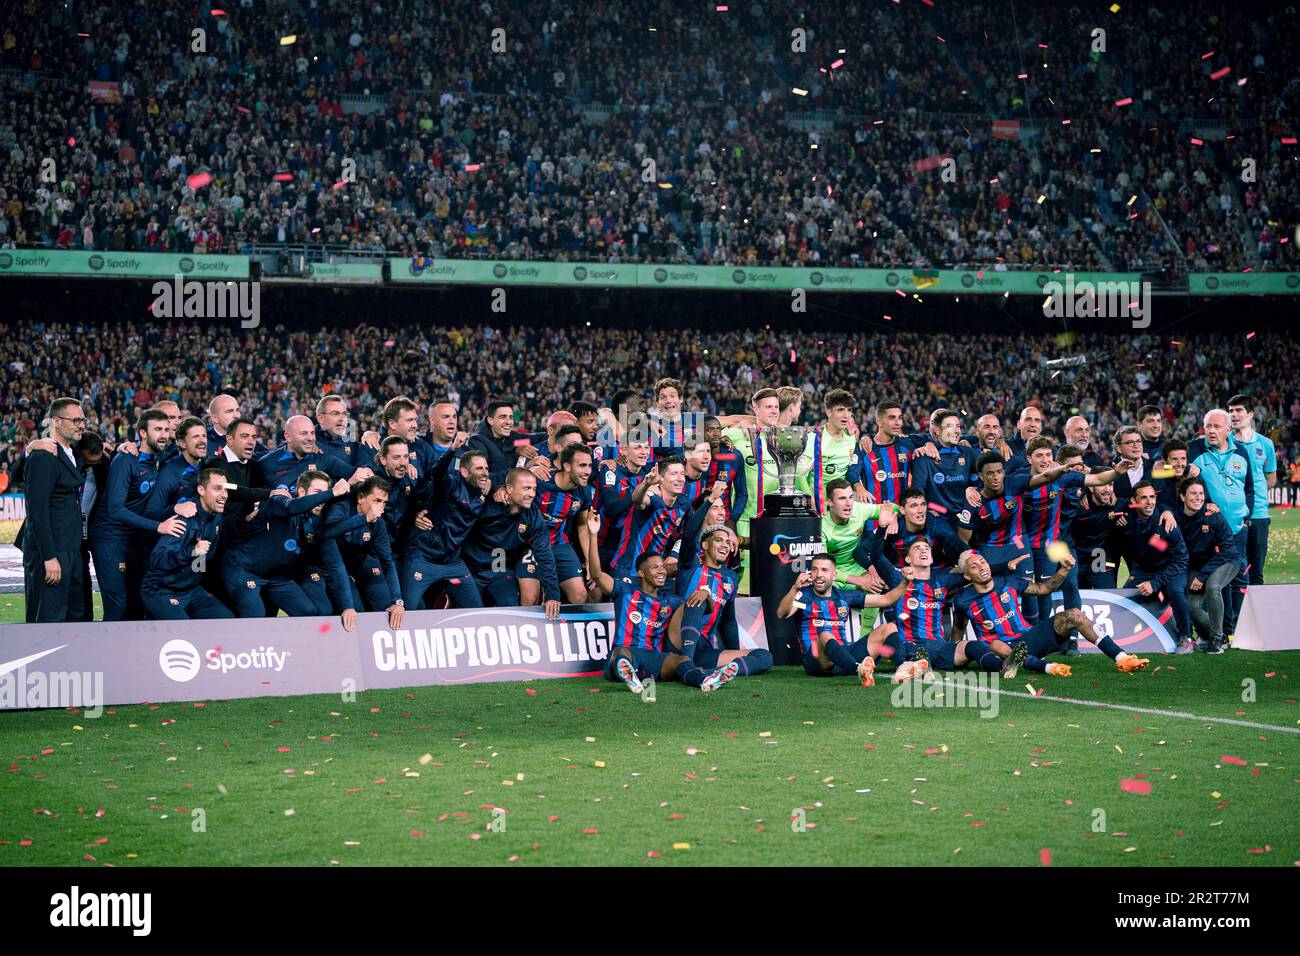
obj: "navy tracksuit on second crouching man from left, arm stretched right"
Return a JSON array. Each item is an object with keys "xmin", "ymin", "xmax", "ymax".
[{"xmin": 221, "ymin": 489, "xmax": 345, "ymax": 618}]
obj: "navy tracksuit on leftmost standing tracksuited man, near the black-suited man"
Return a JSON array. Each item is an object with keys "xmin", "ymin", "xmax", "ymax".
[{"xmin": 90, "ymin": 454, "xmax": 161, "ymax": 620}]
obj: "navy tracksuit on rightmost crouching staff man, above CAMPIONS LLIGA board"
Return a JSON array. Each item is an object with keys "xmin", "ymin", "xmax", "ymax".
[{"xmin": 460, "ymin": 501, "xmax": 562, "ymax": 607}]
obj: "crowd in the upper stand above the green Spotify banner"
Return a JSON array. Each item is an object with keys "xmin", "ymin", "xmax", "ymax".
[{"xmin": 0, "ymin": 0, "xmax": 1300, "ymax": 274}]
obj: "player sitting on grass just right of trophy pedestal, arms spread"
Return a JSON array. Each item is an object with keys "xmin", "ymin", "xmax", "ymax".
[{"xmin": 776, "ymin": 554, "xmax": 910, "ymax": 687}]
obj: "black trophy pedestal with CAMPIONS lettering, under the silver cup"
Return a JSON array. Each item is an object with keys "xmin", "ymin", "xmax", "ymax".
[{"xmin": 749, "ymin": 494, "xmax": 822, "ymax": 666}]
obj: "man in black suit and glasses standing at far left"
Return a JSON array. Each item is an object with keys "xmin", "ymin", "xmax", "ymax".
[{"xmin": 14, "ymin": 398, "xmax": 86, "ymax": 623}]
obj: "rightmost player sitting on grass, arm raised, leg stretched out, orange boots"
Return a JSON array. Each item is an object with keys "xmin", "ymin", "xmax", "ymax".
[{"xmin": 958, "ymin": 551, "xmax": 1151, "ymax": 678}]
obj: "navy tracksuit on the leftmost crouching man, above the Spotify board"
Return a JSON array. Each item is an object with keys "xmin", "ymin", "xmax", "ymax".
[{"xmin": 140, "ymin": 506, "xmax": 234, "ymax": 620}]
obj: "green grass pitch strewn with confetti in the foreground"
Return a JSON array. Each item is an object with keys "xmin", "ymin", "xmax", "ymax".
[{"xmin": 0, "ymin": 512, "xmax": 1300, "ymax": 868}]
